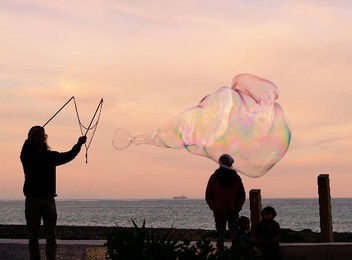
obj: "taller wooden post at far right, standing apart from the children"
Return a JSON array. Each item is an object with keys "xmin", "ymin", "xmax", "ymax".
[{"xmin": 318, "ymin": 174, "xmax": 333, "ymax": 242}]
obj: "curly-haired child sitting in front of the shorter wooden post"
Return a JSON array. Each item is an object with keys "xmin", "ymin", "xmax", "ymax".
[{"xmin": 254, "ymin": 206, "xmax": 281, "ymax": 260}]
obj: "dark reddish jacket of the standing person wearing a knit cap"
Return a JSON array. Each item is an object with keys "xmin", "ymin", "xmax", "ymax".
[{"xmin": 205, "ymin": 166, "xmax": 246, "ymax": 217}]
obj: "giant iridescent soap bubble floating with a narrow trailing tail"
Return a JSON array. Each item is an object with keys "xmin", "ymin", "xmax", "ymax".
[{"xmin": 113, "ymin": 74, "xmax": 291, "ymax": 177}]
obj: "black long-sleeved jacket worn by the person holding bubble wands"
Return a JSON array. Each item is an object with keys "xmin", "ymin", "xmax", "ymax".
[{"xmin": 20, "ymin": 140, "xmax": 81, "ymax": 198}]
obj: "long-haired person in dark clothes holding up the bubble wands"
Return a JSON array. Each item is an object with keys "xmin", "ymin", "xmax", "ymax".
[{"xmin": 20, "ymin": 126, "xmax": 87, "ymax": 260}]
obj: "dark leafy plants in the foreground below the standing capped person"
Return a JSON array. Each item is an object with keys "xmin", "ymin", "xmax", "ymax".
[{"xmin": 105, "ymin": 219, "xmax": 258, "ymax": 260}]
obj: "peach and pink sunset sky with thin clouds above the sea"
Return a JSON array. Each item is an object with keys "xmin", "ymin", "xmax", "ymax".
[{"xmin": 0, "ymin": 0, "xmax": 352, "ymax": 199}]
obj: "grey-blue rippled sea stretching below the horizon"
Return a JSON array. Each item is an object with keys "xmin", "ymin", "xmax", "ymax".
[{"xmin": 0, "ymin": 198, "xmax": 352, "ymax": 232}]
